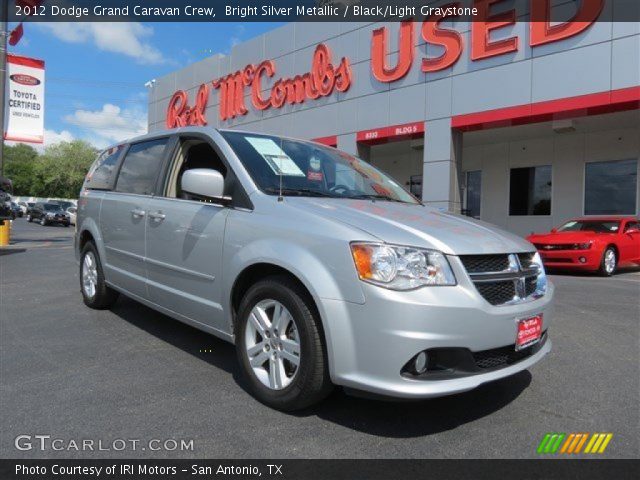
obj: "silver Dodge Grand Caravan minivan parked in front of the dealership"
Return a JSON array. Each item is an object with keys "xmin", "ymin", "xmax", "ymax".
[{"xmin": 75, "ymin": 127, "xmax": 553, "ymax": 410}]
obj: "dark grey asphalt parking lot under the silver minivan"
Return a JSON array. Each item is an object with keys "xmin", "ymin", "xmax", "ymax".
[{"xmin": 0, "ymin": 219, "xmax": 640, "ymax": 458}]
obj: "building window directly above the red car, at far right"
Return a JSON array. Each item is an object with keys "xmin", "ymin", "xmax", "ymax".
[{"xmin": 584, "ymin": 160, "xmax": 638, "ymax": 215}]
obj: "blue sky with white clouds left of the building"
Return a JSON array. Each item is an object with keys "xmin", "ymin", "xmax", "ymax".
[{"xmin": 9, "ymin": 22, "xmax": 281, "ymax": 149}]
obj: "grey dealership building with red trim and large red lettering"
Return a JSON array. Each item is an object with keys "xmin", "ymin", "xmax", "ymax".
[{"xmin": 149, "ymin": 5, "xmax": 640, "ymax": 235}]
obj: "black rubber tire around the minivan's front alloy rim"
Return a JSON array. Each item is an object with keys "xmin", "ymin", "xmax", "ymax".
[{"xmin": 236, "ymin": 275, "xmax": 333, "ymax": 411}]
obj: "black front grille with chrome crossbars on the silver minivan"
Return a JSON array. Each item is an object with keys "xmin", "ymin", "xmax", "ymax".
[{"xmin": 460, "ymin": 252, "xmax": 539, "ymax": 305}]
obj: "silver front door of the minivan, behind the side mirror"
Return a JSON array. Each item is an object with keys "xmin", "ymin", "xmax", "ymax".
[{"xmin": 147, "ymin": 137, "xmax": 234, "ymax": 330}]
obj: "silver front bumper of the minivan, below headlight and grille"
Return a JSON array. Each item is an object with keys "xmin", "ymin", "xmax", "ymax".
[{"xmin": 321, "ymin": 258, "xmax": 554, "ymax": 398}]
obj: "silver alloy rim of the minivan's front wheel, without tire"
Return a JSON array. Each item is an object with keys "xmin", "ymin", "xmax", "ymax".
[{"xmin": 245, "ymin": 299, "xmax": 300, "ymax": 390}]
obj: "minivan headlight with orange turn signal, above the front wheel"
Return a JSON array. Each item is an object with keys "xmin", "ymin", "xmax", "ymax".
[{"xmin": 351, "ymin": 243, "xmax": 456, "ymax": 290}]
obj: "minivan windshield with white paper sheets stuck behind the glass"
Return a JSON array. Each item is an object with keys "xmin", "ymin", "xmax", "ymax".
[{"xmin": 220, "ymin": 132, "xmax": 418, "ymax": 203}]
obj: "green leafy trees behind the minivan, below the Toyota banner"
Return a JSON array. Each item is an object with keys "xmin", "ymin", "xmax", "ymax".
[{"xmin": 5, "ymin": 140, "xmax": 97, "ymax": 198}]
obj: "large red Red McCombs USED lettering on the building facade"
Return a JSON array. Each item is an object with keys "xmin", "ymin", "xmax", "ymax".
[{"xmin": 166, "ymin": 0, "xmax": 605, "ymax": 128}]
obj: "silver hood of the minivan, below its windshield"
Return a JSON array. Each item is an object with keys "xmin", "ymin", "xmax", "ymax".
[{"xmin": 286, "ymin": 197, "xmax": 534, "ymax": 255}]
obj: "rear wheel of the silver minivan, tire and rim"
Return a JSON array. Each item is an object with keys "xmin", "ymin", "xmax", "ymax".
[{"xmin": 80, "ymin": 242, "xmax": 118, "ymax": 310}]
